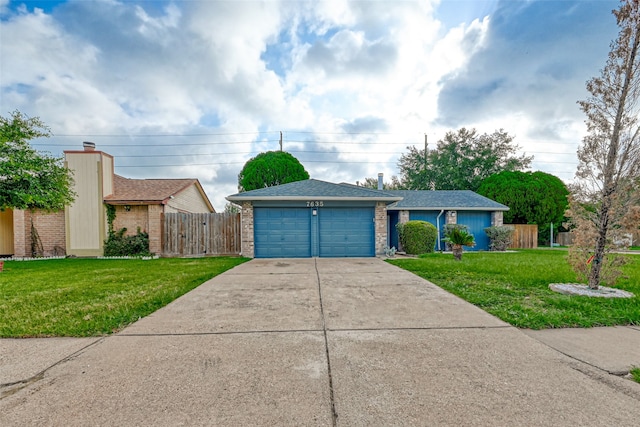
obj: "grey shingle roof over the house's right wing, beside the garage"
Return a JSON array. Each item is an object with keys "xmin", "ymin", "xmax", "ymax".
[{"xmin": 387, "ymin": 190, "xmax": 509, "ymax": 211}]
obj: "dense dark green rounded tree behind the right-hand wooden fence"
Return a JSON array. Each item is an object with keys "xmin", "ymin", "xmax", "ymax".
[{"xmin": 478, "ymin": 171, "xmax": 569, "ymax": 243}]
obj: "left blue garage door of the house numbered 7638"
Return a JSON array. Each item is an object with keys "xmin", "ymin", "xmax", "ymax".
[{"xmin": 253, "ymin": 208, "xmax": 311, "ymax": 258}]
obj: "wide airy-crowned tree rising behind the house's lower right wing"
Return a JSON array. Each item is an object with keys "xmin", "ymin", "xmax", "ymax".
[{"xmin": 398, "ymin": 128, "xmax": 533, "ymax": 191}]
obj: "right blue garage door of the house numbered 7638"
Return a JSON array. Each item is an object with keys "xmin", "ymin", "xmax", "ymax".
[{"xmin": 318, "ymin": 208, "xmax": 375, "ymax": 257}]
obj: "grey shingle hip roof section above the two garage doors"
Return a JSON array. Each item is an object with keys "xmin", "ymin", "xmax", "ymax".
[{"xmin": 227, "ymin": 179, "xmax": 402, "ymax": 202}]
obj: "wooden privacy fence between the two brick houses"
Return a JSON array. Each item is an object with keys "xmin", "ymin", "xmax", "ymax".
[{"xmin": 162, "ymin": 212, "xmax": 241, "ymax": 256}]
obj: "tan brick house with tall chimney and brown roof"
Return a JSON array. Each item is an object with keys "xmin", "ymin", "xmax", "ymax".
[{"xmin": 0, "ymin": 143, "xmax": 215, "ymax": 257}]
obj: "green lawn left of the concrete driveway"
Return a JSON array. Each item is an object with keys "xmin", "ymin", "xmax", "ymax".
[{"xmin": 0, "ymin": 258, "xmax": 247, "ymax": 338}]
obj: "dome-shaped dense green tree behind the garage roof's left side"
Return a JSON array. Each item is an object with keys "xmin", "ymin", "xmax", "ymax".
[{"xmin": 238, "ymin": 151, "xmax": 309, "ymax": 191}]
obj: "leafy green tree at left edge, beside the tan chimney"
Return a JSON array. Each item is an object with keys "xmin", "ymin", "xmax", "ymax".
[{"xmin": 0, "ymin": 110, "xmax": 75, "ymax": 211}]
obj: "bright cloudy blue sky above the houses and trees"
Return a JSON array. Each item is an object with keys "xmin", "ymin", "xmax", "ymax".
[{"xmin": 0, "ymin": 0, "xmax": 618, "ymax": 211}]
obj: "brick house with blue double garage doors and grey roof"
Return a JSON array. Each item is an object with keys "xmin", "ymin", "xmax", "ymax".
[{"xmin": 227, "ymin": 179, "xmax": 509, "ymax": 258}]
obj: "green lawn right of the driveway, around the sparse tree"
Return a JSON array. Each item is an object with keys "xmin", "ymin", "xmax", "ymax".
[{"xmin": 389, "ymin": 249, "xmax": 640, "ymax": 329}]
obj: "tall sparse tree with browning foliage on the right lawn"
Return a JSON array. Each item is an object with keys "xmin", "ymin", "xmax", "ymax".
[{"xmin": 570, "ymin": 0, "xmax": 640, "ymax": 289}]
